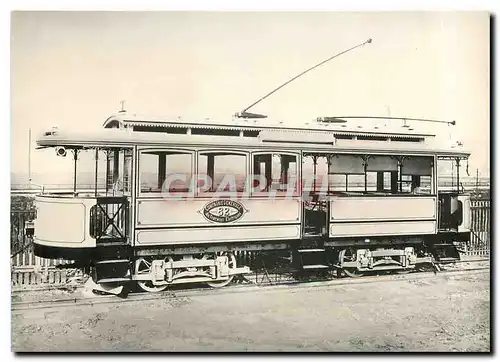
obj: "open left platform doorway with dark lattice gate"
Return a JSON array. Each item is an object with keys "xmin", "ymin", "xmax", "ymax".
[{"xmin": 91, "ymin": 148, "xmax": 132, "ymax": 244}]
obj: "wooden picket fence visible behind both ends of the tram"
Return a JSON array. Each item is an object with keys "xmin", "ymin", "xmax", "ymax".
[{"xmin": 11, "ymin": 195, "xmax": 491, "ymax": 289}]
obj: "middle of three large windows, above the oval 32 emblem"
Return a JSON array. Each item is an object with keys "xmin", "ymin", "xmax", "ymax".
[{"xmin": 198, "ymin": 152, "xmax": 247, "ymax": 193}]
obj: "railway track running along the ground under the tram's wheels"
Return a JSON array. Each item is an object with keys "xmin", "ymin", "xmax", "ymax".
[{"xmin": 11, "ymin": 260, "xmax": 490, "ymax": 312}]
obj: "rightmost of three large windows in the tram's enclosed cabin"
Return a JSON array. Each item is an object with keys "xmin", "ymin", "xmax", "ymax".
[{"xmin": 252, "ymin": 153, "xmax": 297, "ymax": 194}]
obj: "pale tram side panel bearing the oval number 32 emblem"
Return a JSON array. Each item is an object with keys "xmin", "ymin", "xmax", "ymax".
[{"xmin": 135, "ymin": 198, "xmax": 301, "ymax": 246}]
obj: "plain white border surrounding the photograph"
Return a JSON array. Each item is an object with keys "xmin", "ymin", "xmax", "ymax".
[{"xmin": 0, "ymin": 0, "xmax": 500, "ymax": 360}]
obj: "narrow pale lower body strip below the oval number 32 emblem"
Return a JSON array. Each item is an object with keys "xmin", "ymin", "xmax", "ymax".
[{"xmin": 135, "ymin": 224, "xmax": 300, "ymax": 246}]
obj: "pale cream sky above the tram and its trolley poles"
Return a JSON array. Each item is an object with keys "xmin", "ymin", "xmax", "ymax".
[{"xmin": 11, "ymin": 11, "xmax": 490, "ymax": 184}]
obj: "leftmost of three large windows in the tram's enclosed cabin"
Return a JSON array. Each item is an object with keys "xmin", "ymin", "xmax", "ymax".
[{"xmin": 139, "ymin": 151, "xmax": 192, "ymax": 193}]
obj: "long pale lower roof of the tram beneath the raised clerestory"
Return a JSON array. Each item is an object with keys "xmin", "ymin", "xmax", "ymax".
[{"xmin": 37, "ymin": 125, "xmax": 470, "ymax": 157}]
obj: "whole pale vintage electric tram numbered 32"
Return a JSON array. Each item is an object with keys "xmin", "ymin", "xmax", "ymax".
[{"xmin": 34, "ymin": 112, "xmax": 470, "ymax": 292}]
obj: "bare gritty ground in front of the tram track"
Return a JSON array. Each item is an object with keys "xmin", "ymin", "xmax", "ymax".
[{"xmin": 12, "ymin": 272, "xmax": 490, "ymax": 352}]
